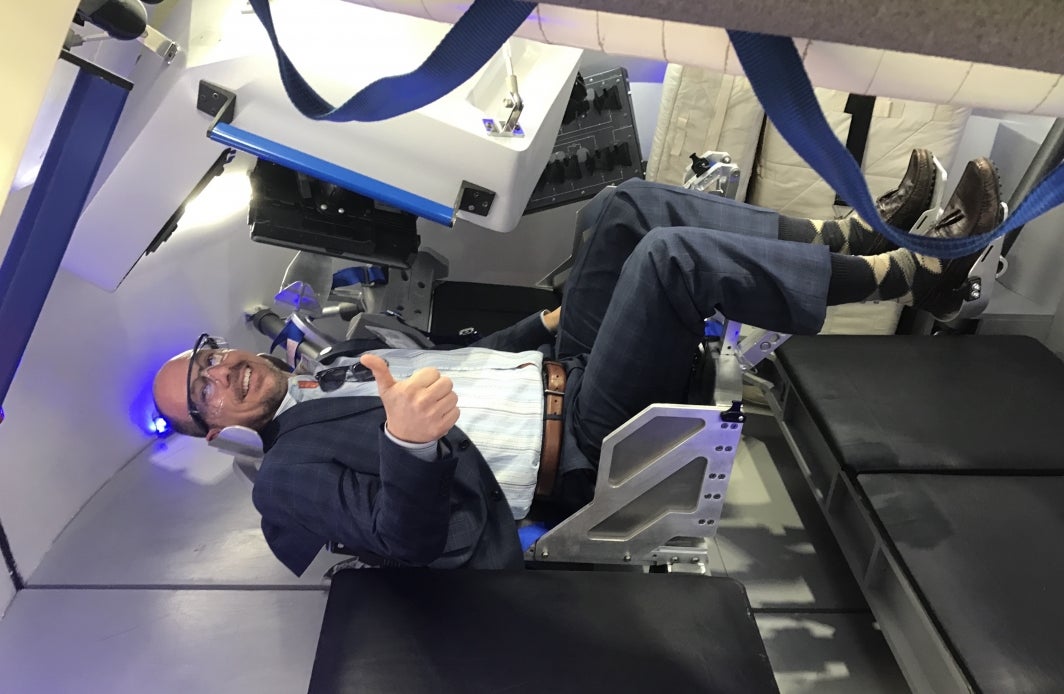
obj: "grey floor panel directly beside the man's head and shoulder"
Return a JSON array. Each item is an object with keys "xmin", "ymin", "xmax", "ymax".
[{"xmin": 28, "ymin": 436, "xmax": 343, "ymax": 586}]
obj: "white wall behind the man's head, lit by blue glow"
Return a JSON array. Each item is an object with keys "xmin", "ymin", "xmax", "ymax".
[{"xmin": 0, "ymin": 176, "xmax": 293, "ymax": 575}]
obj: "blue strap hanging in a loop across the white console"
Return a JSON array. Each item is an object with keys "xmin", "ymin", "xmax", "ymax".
[{"xmin": 244, "ymin": 0, "xmax": 536, "ymax": 122}]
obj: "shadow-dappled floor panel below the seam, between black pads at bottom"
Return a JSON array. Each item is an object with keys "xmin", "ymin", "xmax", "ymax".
[{"xmin": 754, "ymin": 612, "xmax": 909, "ymax": 694}]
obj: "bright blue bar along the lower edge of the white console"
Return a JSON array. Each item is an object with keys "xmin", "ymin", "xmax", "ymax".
[{"xmin": 207, "ymin": 122, "xmax": 456, "ymax": 227}]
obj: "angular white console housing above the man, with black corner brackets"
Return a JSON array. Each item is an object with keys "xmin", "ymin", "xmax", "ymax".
[{"xmin": 64, "ymin": 1, "xmax": 581, "ymax": 291}]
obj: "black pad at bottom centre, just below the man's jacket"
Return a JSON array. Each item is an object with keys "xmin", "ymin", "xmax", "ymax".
[{"xmin": 310, "ymin": 569, "xmax": 779, "ymax": 694}]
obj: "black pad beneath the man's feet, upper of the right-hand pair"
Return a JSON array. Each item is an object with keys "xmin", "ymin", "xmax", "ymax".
[{"xmin": 779, "ymin": 335, "xmax": 1064, "ymax": 473}]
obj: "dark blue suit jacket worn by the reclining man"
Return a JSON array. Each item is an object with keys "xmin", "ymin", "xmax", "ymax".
[{"xmin": 252, "ymin": 315, "xmax": 553, "ymax": 575}]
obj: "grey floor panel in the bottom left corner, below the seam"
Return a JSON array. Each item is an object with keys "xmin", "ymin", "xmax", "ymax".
[{"xmin": 0, "ymin": 589, "xmax": 326, "ymax": 694}]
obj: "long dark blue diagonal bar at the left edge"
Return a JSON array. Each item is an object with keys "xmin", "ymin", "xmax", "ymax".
[{"xmin": 0, "ymin": 69, "xmax": 129, "ymax": 412}]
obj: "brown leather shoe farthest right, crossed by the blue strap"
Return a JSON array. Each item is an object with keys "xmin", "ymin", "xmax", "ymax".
[{"xmin": 913, "ymin": 156, "xmax": 1001, "ymax": 319}]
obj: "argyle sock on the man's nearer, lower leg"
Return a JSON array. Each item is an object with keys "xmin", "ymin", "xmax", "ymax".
[{"xmin": 828, "ymin": 248, "xmax": 946, "ymax": 305}]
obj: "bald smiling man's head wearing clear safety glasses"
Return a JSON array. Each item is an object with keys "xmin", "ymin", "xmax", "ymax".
[{"xmin": 152, "ymin": 335, "xmax": 288, "ymax": 440}]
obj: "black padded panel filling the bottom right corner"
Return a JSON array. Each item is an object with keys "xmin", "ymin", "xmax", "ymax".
[{"xmin": 858, "ymin": 474, "xmax": 1064, "ymax": 694}]
